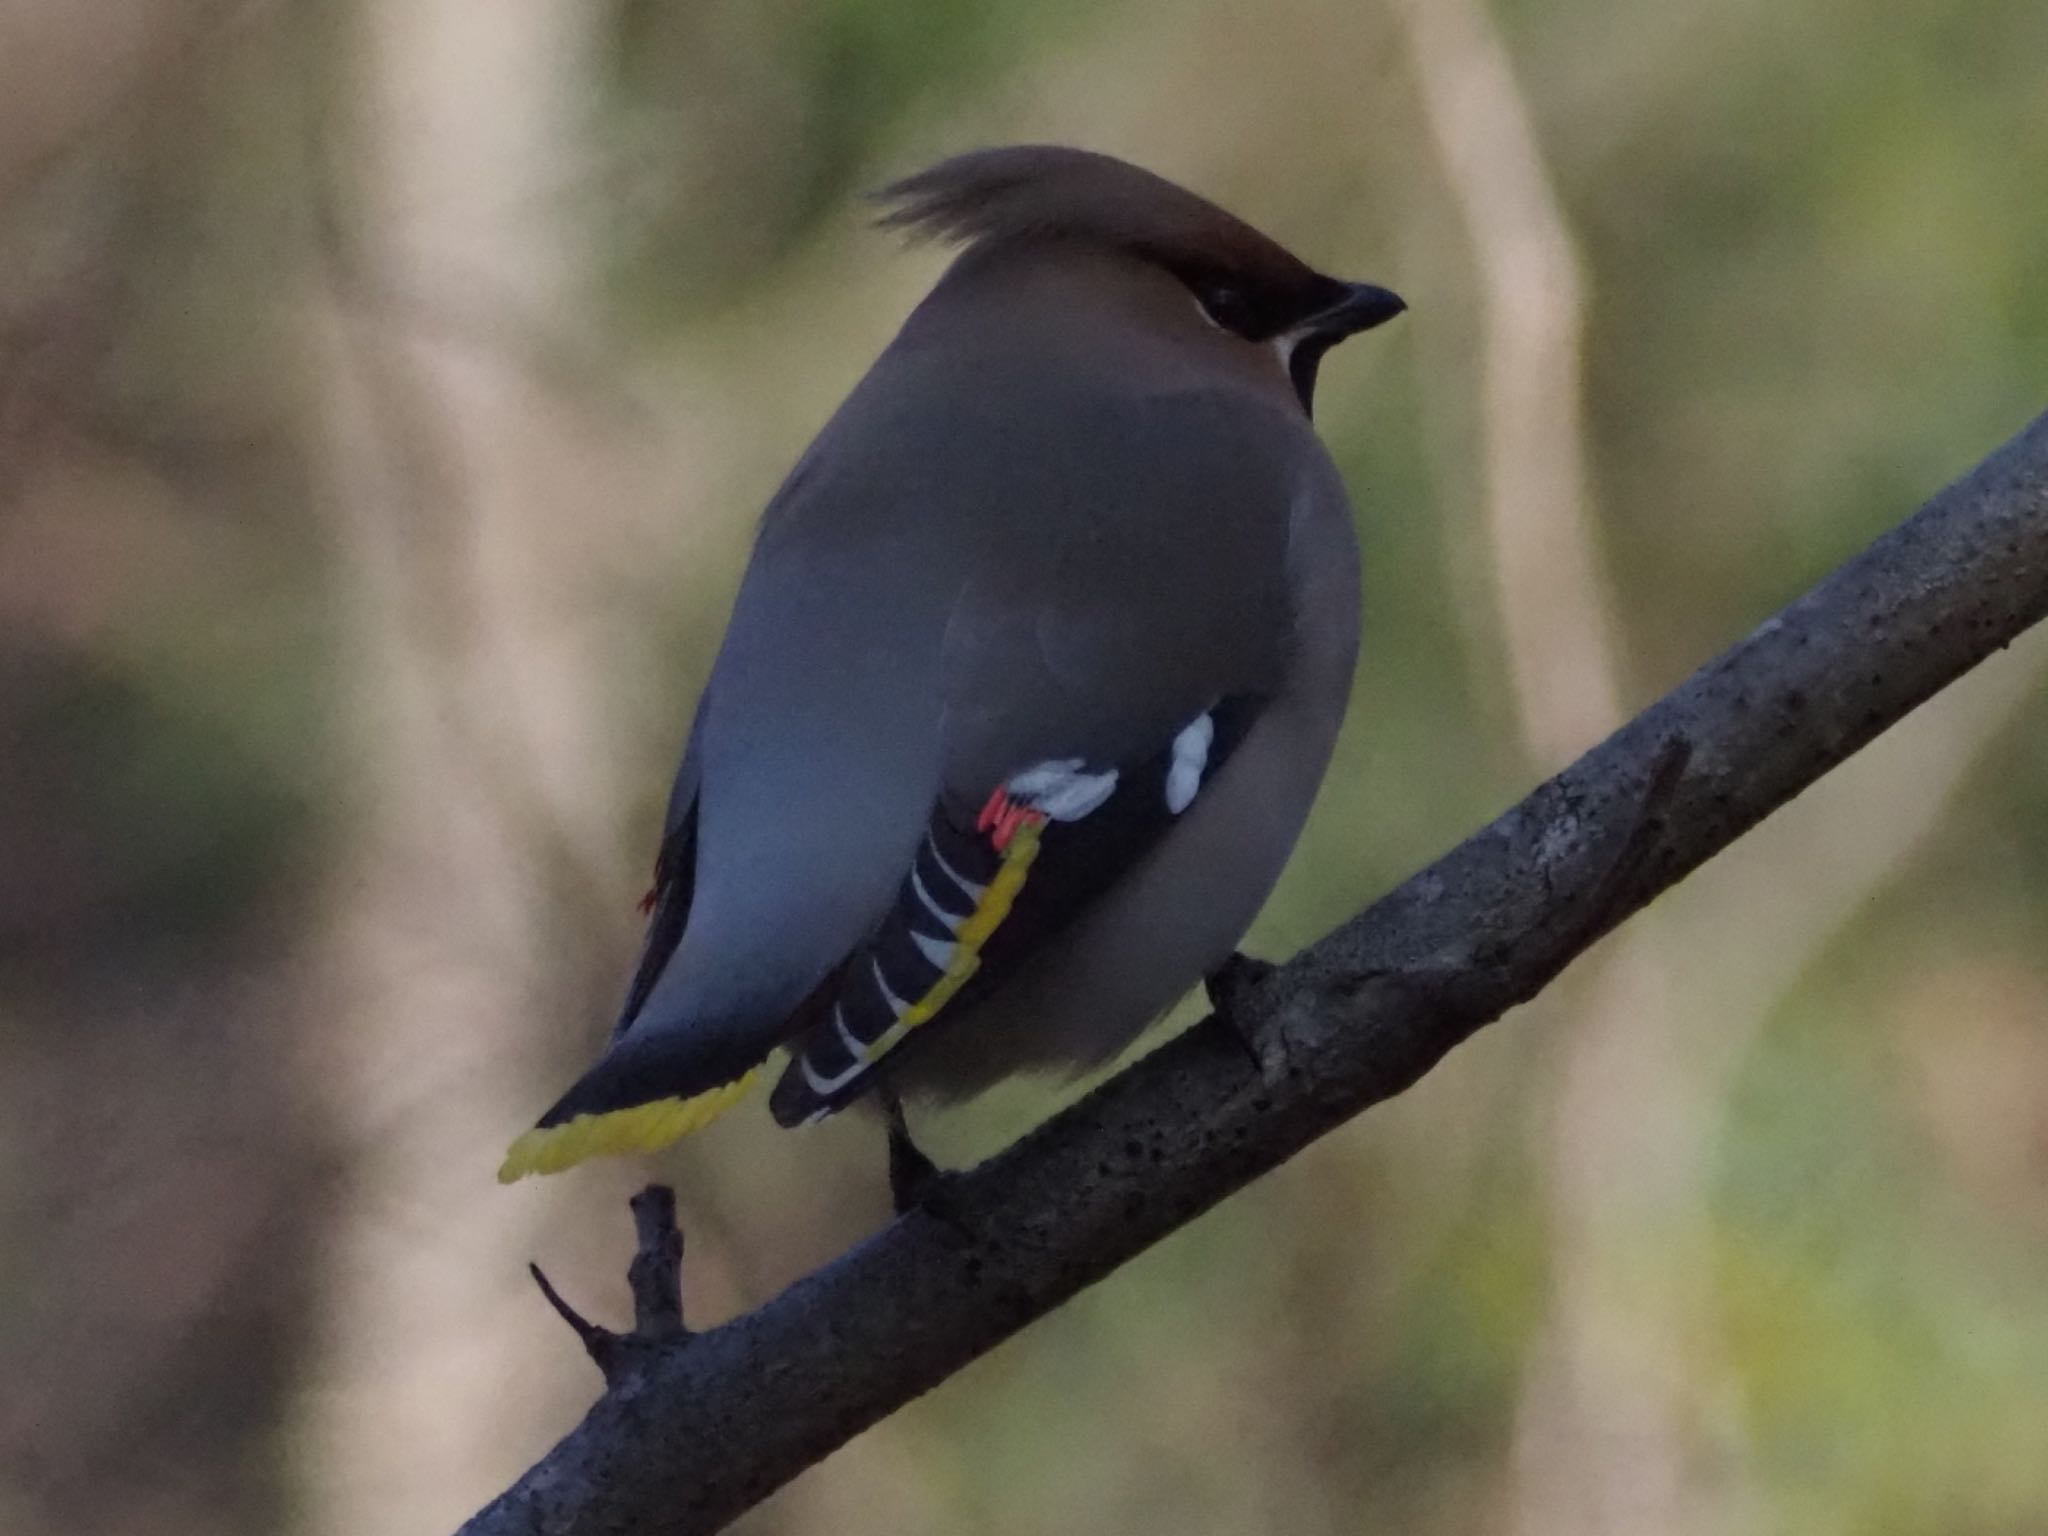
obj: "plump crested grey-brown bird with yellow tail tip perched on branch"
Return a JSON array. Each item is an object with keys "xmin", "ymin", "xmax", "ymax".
[{"xmin": 500, "ymin": 145, "xmax": 1405, "ymax": 1204}]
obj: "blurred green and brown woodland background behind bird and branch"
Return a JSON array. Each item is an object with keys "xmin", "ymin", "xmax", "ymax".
[{"xmin": 0, "ymin": 0, "xmax": 2048, "ymax": 1536}]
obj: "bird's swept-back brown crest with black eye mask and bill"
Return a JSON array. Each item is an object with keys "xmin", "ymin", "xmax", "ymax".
[{"xmin": 877, "ymin": 143, "xmax": 1407, "ymax": 410}]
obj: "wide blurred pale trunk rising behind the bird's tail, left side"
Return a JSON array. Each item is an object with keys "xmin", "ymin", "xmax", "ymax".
[{"xmin": 305, "ymin": 0, "xmax": 629, "ymax": 1532}]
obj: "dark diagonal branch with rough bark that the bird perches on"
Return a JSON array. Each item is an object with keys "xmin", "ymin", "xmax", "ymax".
[{"xmin": 463, "ymin": 416, "xmax": 2048, "ymax": 1536}]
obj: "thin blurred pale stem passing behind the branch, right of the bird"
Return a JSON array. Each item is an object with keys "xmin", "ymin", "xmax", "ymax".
[{"xmin": 1401, "ymin": 0, "xmax": 1741, "ymax": 1536}]
